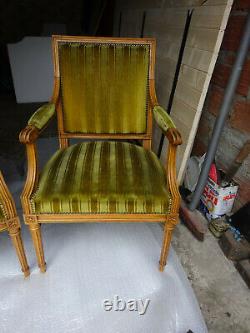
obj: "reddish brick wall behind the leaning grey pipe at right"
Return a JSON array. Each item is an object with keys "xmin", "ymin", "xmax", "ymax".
[{"xmin": 193, "ymin": 0, "xmax": 250, "ymax": 210}]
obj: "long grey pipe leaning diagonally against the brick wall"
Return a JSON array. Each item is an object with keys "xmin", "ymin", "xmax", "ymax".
[{"xmin": 188, "ymin": 13, "xmax": 250, "ymax": 211}]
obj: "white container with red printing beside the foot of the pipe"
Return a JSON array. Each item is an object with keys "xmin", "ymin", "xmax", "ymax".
[{"xmin": 201, "ymin": 177, "xmax": 238, "ymax": 220}]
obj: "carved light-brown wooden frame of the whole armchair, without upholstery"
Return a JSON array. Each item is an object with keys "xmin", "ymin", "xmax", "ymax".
[{"xmin": 20, "ymin": 36, "xmax": 182, "ymax": 272}]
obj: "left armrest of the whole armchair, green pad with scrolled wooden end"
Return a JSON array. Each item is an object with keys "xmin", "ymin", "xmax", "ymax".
[{"xmin": 19, "ymin": 103, "xmax": 55, "ymax": 144}]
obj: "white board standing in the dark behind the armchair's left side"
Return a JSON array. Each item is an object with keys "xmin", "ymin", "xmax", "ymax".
[{"xmin": 8, "ymin": 37, "xmax": 53, "ymax": 103}]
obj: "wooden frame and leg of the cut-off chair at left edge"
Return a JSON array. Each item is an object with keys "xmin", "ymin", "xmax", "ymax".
[{"xmin": 0, "ymin": 171, "xmax": 30, "ymax": 277}]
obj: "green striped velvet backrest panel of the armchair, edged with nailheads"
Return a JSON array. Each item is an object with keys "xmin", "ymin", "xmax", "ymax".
[{"xmin": 59, "ymin": 42, "xmax": 150, "ymax": 134}]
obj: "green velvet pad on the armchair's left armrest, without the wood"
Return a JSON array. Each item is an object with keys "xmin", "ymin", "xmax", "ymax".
[{"xmin": 28, "ymin": 103, "xmax": 55, "ymax": 130}]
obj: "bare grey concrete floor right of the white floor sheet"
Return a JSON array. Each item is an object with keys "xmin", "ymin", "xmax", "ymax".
[{"xmin": 172, "ymin": 224, "xmax": 250, "ymax": 333}]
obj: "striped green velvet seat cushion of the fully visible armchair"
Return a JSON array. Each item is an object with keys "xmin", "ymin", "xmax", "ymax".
[{"xmin": 32, "ymin": 141, "xmax": 170, "ymax": 214}]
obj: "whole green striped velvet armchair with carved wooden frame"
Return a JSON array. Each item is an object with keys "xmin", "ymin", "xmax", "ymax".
[{"xmin": 20, "ymin": 36, "xmax": 181, "ymax": 272}]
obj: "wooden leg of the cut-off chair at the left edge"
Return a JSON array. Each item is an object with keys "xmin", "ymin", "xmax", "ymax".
[{"xmin": 9, "ymin": 228, "xmax": 30, "ymax": 277}]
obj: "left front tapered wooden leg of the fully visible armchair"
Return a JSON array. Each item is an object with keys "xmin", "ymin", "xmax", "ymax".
[{"xmin": 29, "ymin": 223, "xmax": 46, "ymax": 273}]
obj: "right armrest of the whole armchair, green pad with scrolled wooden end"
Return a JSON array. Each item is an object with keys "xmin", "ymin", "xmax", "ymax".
[{"xmin": 153, "ymin": 105, "xmax": 182, "ymax": 146}]
